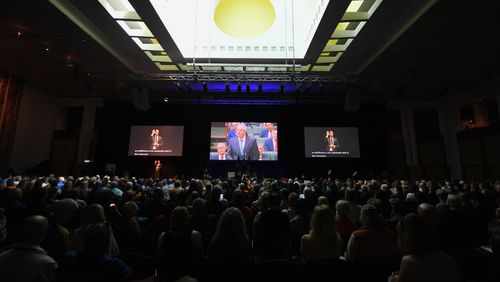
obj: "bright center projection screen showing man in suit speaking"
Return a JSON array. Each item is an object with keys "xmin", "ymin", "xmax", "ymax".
[{"xmin": 209, "ymin": 122, "xmax": 279, "ymax": 161}]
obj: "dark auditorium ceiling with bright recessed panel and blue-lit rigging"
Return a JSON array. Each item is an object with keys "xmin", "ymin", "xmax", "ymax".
[{"xmin": 0, "ymin": 0, "xmax": 500, "ymax": 101}]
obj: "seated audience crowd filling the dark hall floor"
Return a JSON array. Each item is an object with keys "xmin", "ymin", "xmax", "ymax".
[{"xmin": 0, "ymin": 175, "xmax": 500, "ymax": 282}]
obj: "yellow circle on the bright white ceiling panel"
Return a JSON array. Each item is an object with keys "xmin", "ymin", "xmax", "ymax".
[{"xmin": 214, "ymin": 0, "xmax": 276, "ymax": 39}]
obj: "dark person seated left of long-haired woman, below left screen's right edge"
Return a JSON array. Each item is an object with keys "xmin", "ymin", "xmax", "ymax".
[{"xmin": 158, "ymin": 206, "xmax": 203, "ymax": 281}]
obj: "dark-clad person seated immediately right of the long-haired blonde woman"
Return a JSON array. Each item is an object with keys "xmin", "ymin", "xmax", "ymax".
[{"xmin": 346, "ymin": 204, "xmax": 399, "ymax": 264}]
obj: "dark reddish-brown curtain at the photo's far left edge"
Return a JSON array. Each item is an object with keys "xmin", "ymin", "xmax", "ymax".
[{"xmin": 0, "ymin": 73, "xmax": 23, "ymax": 172}]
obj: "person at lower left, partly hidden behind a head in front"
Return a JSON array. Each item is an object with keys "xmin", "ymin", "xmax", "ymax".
[{"xmin": 69, "ymin": 204, "xmax": 120, "ymax": 256}]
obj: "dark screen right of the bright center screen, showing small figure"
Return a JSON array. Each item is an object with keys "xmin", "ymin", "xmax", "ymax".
[{"xmin": 304, "ymin": 127, "xmax": 360, "ymax": 158}]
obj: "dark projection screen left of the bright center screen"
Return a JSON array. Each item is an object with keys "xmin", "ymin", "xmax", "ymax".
[{"xmin": 128, "ymin": 125, "xmax": 184, "ymax": 157}]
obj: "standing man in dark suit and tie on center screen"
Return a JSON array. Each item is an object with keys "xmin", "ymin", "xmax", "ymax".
[{"xmin": 229, "ymin": 123, "xmax": 259, "ymax": 161}]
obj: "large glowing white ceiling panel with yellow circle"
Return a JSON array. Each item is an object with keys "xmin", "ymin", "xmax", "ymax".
[{"xmin": 150, "ymin": 0, "xmax": 330, "ymax": 59}]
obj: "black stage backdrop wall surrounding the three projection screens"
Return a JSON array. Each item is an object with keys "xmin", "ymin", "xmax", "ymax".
[{"xmin": 94, "ymin": 103, "xmax": 388, "ymax": 177}]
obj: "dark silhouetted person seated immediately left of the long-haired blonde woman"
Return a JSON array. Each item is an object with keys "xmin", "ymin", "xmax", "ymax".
[{"xmin": 253, "ymin": 192, "xmax": 290, "ymax": 261}]
